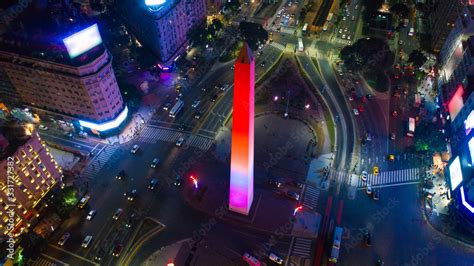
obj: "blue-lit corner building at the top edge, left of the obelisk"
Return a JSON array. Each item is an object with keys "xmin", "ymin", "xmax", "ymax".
[{"xmin": 118, "ymin": 0, "xmax": 207, "ymax": 67}]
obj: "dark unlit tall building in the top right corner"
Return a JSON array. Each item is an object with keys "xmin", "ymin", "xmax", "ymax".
[{"xmin": 430, "ymin": 0, "xmax": 464, "ymax": 52}]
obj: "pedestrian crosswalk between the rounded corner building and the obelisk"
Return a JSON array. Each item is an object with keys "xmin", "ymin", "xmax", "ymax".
[{"xmin": 140, "ymin": 127, "xmax": 214, "ymax": 150}]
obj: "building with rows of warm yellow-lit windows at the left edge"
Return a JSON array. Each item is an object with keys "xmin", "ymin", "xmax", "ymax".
[{"xmin": 0, "ymin": 124, "xmax": 62, "ymax": 236}]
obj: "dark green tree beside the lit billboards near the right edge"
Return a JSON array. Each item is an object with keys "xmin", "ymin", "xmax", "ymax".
[{"xmin": 415, "ymin": 121, "xmax": 446, "ymax": 153}]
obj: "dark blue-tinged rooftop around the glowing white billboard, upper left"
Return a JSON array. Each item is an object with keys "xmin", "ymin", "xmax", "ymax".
[{"xmin": 0, "ymin": 0, "xmax": 105, "ymax": 66}]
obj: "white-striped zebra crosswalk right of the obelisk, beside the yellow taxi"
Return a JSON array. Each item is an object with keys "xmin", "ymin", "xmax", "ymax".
[{"xmin": 357, "ymin": 168, "xmax": 420, "ymax": 188}]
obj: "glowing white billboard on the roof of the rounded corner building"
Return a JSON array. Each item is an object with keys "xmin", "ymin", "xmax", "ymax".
[{"xmin": 63, "ymin": 24, "xmax": 102, "ymax": 58}]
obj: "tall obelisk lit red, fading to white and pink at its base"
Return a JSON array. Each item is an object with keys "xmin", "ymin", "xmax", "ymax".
[{"xmin": 229, "ymin": 43, "xmax": 255, "ymax": 215}]
